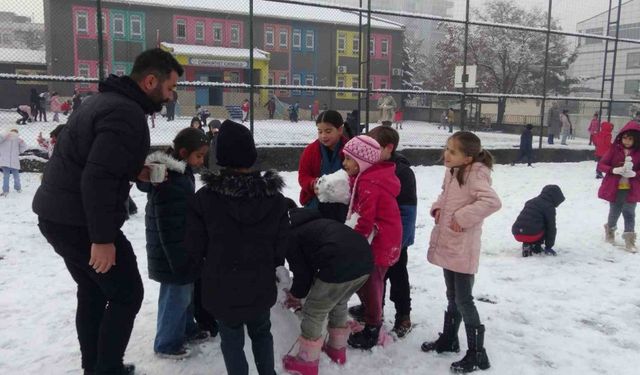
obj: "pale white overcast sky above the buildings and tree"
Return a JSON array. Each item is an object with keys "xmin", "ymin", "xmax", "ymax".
[{"xmin": 0, "ymin": 0, "xmax": 626, "ymax": 31}]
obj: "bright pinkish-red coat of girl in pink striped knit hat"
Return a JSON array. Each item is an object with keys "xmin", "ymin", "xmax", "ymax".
[{"xmin": 347, "ymin": 161, "xmax": 402, "ymax": 267}]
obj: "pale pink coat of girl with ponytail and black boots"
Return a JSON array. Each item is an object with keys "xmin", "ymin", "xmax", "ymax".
[{"xmin": 427, "ymin": 163, "xmax": 502, "ymax": 274}]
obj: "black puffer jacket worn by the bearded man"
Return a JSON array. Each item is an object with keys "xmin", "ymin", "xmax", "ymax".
[{"xmin": 33, "ymin": 76, "xmax": 158, "ymax": 243}]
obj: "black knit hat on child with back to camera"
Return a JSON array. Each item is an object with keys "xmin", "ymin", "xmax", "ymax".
[{"xmin": 216, "ymin": 120, "xmax": 258, "ymax": 168}]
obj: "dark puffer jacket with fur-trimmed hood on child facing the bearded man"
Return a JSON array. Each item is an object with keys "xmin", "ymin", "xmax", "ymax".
[{"xmin": 138, "ymin": 151, "xmax": 198, "ymax": 284}]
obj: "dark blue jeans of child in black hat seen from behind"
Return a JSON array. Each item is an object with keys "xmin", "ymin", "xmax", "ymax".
[{"xmin": 218, "ymin": 311, "xmax": 276, "ymax": 375}]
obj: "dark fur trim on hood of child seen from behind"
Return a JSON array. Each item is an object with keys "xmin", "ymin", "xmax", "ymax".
[{"xmin": 202, "ymin": 170, "xmax": 284, "ymax": 198}]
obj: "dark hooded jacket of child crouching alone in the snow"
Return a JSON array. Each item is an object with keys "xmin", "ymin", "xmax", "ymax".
[{"xmin": 511, "ymin": 185, "xmax": 564, "ymax": 248}]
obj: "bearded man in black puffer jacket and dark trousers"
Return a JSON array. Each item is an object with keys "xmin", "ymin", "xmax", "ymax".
[{"xmin": 33, "ymin": 49, "xmax": 183, "ymax": 374}]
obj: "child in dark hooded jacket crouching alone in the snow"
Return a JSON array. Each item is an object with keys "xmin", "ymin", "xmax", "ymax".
[{"xmin": 511, "ymin": 185, "xmax": 564, "ymax": 257}]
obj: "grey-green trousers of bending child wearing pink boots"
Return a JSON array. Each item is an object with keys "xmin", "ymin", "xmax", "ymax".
[{"xmin": 300, "ymin": 275, "xmax": 369, "ymax": 340}]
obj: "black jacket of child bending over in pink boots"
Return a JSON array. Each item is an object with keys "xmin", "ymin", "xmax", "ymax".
[{"xmin": 287, "ymin": 208, "xmax": 373, "ymax": 298}]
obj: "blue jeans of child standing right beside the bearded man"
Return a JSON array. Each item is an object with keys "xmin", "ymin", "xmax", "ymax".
[{"xmin": 153, "ymin": 283, "xmax": 198, "ymax": 353}]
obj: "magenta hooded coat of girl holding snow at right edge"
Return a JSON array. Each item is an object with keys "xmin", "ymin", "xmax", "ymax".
[{"xmin": 598, "ymin": 120, "xmax": 640, "ymax": 203}]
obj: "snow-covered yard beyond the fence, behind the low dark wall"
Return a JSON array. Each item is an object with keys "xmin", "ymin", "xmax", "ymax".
[{"xmin": 0, "ymin": 112, "xmax": 593, "ymax": 149}]
